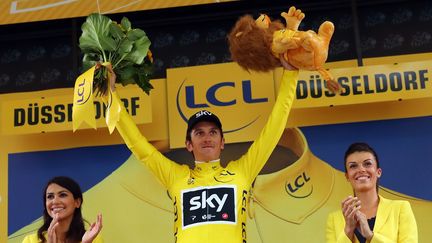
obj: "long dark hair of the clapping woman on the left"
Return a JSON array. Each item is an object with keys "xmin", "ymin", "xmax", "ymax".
[{"xmin": 38, "ymin": 176, "xmax": 85, "ymax": 242}]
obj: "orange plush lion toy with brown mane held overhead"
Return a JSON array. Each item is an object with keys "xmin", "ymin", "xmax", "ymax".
[{"xmin": 228, "ymin": 7, "xmax": 340, "ymax": 93}]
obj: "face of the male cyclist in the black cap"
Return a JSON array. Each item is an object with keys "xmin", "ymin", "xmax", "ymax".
[{"xmin": 186, "ymin": 121, "xmax": 225, "ymax": 162}]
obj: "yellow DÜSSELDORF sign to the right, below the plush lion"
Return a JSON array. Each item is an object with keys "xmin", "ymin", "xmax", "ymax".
[{"xmin": 295, "ymin": 61, "xmax": 432, "ymax": 108}]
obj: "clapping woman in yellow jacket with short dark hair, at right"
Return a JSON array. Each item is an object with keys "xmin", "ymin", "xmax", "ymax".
[{"xmin": 326, "ymin": 143, "xmax": 418, "ymax": 243}]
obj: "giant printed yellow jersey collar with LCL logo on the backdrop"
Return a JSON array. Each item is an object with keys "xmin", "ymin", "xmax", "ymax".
[{"xmin": 253, "ymin": 129, "xmax": 335, "ymax": 223}]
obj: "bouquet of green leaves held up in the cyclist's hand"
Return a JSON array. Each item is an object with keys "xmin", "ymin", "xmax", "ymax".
[{"xmin": 79, "ymin": 13, "xmax": 153, "ymax": 95}]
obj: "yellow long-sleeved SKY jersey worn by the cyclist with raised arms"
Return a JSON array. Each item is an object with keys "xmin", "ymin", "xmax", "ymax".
[{"xmin": 114, "ymin": 71, "xmax": 298, "ymax": 243}]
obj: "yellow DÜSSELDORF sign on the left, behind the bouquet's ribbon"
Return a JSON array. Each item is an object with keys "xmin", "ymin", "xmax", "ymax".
[{"xmin": 1, "ymin": 86, "xmax": 152, "ymax": 135}]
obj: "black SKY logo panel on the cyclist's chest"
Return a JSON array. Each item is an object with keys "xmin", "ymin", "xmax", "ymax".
[{"xmin": 181, "ymin": 185, "xmax": 237, "ymax": 228}]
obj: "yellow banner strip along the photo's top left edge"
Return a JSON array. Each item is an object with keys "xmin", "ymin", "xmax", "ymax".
[{"xmin": 0, "ymin": 0, "xmax": 234, "ymax": 25}]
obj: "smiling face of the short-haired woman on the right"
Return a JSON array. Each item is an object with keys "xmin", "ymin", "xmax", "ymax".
[{"xmin": 345, "ymin": 152, "xmax": 382, "ymax": 193}]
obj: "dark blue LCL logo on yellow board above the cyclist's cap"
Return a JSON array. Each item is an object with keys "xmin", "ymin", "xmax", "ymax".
[{"xmin": 176, "ymin": 79, "xmax": 268, "ymax": 133}]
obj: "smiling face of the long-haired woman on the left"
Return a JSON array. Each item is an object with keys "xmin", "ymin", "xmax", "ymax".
[{"xmin": 45, "ymin": 183, "xmax": 81, "ymax": 221}]
